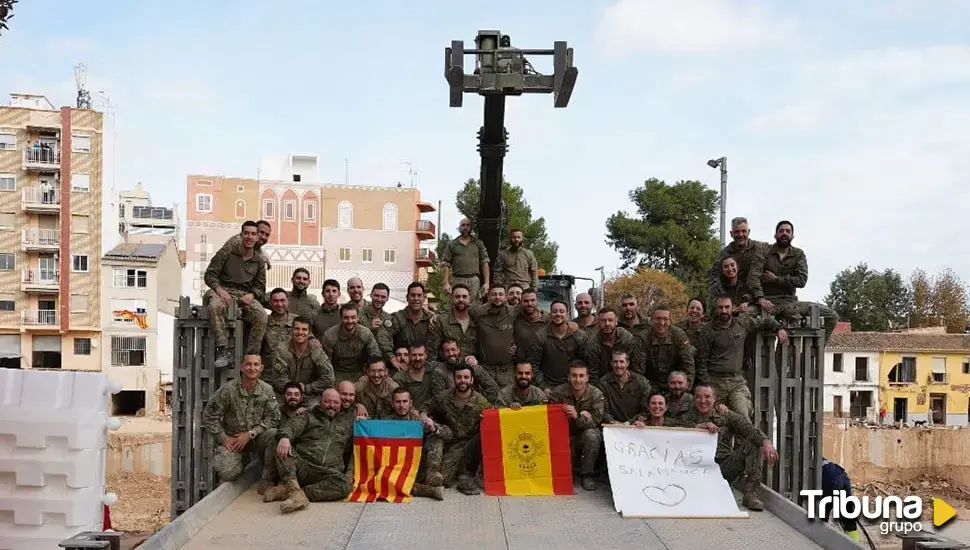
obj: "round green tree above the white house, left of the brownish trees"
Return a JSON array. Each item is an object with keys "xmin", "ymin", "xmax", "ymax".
[{"xmin": 825, "ymin": 263, "xmax": 912, "ymax": 332}]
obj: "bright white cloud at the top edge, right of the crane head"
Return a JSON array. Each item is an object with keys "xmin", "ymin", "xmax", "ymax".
[{"xmin": 596, "ymin": 0, "xmax": 796, "ymax": 56}]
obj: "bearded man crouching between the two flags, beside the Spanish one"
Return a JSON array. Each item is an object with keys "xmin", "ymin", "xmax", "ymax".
[{"xmin": 422, "ymin": 366, "xmax": 492, "ymax": 495}]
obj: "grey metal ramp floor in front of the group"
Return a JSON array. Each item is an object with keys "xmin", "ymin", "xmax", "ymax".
[{"xmin": 182, "ymin": 484, "xmax": 821, "ymax": 550}]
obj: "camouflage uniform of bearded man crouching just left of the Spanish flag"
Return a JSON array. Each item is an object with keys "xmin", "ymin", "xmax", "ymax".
[{"xmin": 428, "ymin": 390, "xmax": 492, "ymax": 486}]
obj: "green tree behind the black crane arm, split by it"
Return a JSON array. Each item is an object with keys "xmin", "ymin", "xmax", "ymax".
[{"xmin": 455, "ymin": 179, "xmax": 559, "ymax": 273}]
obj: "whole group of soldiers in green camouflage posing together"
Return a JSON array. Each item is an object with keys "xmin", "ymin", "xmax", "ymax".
[{"xmin": 204, "ymin": 218, "xmax": 835, "ymax": 513}]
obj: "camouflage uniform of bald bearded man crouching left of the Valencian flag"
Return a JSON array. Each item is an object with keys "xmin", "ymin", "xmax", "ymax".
[{"xmin": 276, "ymin": 407, "xmax": 354, "ymax": 502}]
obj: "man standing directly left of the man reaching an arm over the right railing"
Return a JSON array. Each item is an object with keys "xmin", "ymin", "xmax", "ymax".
[{"xmin": 638, "ymin": 306, "xmax": 694, "ymax": 389}]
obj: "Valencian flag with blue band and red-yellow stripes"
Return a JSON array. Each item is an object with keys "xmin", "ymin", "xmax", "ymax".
[{"xmin": 347, "ymin": 420, "xmax": 424, "ymax": 502}]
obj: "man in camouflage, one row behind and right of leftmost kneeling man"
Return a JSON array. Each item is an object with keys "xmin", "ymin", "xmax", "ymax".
[{"xmin": 273, "ymin": 317, "xmax": 334, "ymax": 407}]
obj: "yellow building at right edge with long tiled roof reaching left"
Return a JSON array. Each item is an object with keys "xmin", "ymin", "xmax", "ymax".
[{"xmin": 826, "ymin": 331, "xmax": 970, "ymax": 426}]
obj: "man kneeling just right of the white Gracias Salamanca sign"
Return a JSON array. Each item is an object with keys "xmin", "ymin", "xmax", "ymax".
[{"xmin": 681, "ymin": 382, "xmax": 778, "ymax": 512}]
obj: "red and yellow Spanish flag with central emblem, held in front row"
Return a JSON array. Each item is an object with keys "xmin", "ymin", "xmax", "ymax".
[{"xmin": 481, "ymin": 405, "xmax": 573, "ymax": 496}]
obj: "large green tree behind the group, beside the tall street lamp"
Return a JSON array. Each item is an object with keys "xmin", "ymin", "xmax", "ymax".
[{"xmin": 606, "ymin": 178, "xmax": 719, "ymax": 294}]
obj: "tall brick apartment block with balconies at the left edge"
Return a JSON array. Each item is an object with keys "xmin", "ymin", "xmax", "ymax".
[{"xmin": 0, "ymin": 94, "xmax": 103, "ymax": 370}]
